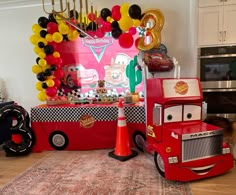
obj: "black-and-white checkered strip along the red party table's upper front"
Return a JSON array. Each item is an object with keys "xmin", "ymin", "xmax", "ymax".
[{"xmin": 31, "ymin": 105, "xmax": 145, "ymax": 123}]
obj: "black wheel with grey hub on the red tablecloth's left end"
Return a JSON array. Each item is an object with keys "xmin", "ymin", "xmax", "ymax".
[{"xmin": 48, "ymin": 131, "xmax": 69, "ymax": 150}]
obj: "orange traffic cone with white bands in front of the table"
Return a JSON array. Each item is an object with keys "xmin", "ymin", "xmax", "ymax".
[{"xmin": 109, "ymin": 101, "xmax": 138, "ymax": 161}]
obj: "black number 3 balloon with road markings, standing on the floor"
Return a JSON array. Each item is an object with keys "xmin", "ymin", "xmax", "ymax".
[{"xmin": 0, "ymin": 105, "xmax": 35, "ymax": 156}]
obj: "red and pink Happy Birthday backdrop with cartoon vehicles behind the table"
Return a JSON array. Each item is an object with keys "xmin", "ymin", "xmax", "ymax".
[{"xmin": 57, "ymin": 33, "xmax": 142, "ymax": 93}]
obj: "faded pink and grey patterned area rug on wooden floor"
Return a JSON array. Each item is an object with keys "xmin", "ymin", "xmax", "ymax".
[{"xmin": 0, "ymin": 150, "xmax": 191, "ymax": 195}]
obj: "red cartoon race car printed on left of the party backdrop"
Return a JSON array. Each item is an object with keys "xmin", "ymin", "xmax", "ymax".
[{"xmin": 62, "ymin": 64, "xmax": 98, "ymax": 88}]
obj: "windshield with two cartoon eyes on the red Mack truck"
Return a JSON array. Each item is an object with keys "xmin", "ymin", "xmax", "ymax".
[{"xmin": 164, "ymin": 105, "xmax": 201, "ymax": 123}]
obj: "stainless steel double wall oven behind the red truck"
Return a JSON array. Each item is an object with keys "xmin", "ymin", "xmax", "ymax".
[{"xmin": 198, "ymin": 46, "xmax": 236, "ymax": 120}]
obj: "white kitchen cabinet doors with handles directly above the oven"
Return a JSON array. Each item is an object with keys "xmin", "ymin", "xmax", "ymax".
[{"xmin": 198, "ymin": 5, "xmax": 236, "ymax": 46}]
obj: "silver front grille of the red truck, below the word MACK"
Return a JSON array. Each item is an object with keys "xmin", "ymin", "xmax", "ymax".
[{"xmin": 182, "ymin": 133, "xmax": 223, "ymax": 162}]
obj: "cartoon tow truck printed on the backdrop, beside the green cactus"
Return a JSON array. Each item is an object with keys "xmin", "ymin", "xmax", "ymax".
[{"xmin": 104, "ymin": 53, "xmax": 130, "ymax": 87}]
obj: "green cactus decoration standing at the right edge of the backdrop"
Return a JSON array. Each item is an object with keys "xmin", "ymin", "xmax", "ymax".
[{"xmin": 126, "ymin": 56, "xmax": 142, "ymax": 93}]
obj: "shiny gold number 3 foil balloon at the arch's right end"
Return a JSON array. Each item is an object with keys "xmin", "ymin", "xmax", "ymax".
[{"xmin": 137, "ymin": 10, "xmax": 165, "ymax": 51}]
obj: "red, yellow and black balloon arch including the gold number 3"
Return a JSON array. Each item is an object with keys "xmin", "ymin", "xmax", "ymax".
[{"xmin": 30, "ymin": 3, "xmax": 164, "ymax": 101}]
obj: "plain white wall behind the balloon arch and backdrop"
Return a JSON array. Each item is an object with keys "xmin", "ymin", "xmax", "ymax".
[{"xmin": 0, "ymin": 0, "xmax": 197, "ymax": 111}]
